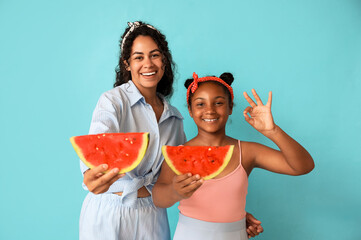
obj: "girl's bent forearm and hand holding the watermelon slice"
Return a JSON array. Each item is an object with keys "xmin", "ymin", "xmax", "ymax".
[{"xmin": 152, "ymin": 161, "xmax": 203, "ymax": 208}]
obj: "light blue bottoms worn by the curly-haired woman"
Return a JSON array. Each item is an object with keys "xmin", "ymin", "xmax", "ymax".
[{"xmin": 79, "ymin": 193, "xmax": 170, "ymax": 240}]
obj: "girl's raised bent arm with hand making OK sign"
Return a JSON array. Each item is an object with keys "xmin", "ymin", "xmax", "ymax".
[{"xmin": 243, "ymin": 89, "xmax": 314, "ymax": 175}]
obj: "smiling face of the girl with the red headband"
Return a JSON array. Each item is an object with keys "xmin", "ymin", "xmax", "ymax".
[{"xmin": 188, "ymin": 81, "xmax": 233, "ymax": 133}]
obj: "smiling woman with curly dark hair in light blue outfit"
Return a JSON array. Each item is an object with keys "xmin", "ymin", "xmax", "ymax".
[{"xmin": 79, "ymin": 22, "xmax": 261, "ymax": 240}]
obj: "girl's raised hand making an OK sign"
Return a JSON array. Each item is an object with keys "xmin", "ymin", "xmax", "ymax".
[{"xmin": 243, "ymin": 89, "xmax": 276, "ymax": 134}]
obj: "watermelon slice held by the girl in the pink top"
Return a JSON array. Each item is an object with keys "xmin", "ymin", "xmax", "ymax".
[{"xmin": 162, "ymin": 145, "xmax": 234, "ymax": 180}]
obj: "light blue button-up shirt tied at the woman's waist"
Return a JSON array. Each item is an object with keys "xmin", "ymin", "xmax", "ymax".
[{"xmin": 80, "ymin": 81, "xmax": 186, "ymax": 206}]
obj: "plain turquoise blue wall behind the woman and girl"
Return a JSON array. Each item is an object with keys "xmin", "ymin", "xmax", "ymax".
[{"xmin": 0, "ymin": 0, "xmax": 361, "ymax": 240}]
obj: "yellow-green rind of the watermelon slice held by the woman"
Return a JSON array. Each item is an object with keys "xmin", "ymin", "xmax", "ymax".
[{"xmin": 70, "ymin": 132, "xmax": 149, "ymax": 174}]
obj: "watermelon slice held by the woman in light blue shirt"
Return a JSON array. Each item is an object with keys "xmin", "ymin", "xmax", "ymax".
[{"xmin": 70, "ymin": 132, "xmax": 149, "ymax": 174}]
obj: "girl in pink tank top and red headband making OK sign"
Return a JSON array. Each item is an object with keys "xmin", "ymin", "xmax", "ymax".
[{"xmin": 153, "ymin": 73, "xmax": 314, "ymax": 240}]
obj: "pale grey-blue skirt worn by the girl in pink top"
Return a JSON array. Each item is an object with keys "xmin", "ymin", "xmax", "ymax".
[{"xmin": 173, "ymin": 213, "xmax": 248, "ymax": 240}]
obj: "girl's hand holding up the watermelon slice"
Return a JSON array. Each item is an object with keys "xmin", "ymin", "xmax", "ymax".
[{"xmin": 172, "ymin": 173, "xmax": 204, "ymax": 199}]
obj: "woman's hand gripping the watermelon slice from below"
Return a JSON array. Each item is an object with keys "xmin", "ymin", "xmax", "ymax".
[{"xmin": 84, "ymin": 164, "xmax": 125, "ymax": 194}]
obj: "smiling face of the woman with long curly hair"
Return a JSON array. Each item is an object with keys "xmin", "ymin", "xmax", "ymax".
[{"xmin": 125, "ymin": 36, "xmax": 164, "ymax": 93}]
